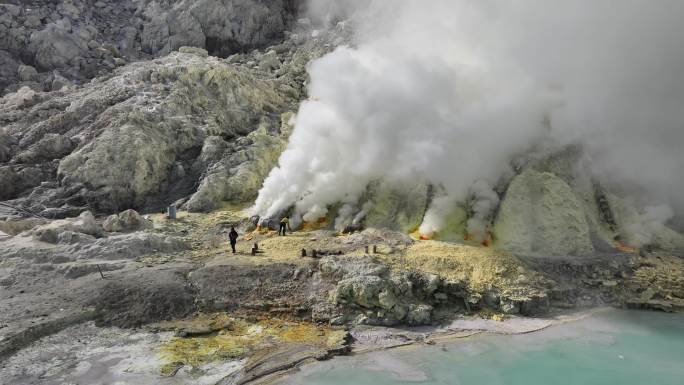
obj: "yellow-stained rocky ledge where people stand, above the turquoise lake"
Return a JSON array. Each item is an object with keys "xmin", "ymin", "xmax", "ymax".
[{"xmin": 0, "ymin": 207, "xmax": 684, "ymax": 378}]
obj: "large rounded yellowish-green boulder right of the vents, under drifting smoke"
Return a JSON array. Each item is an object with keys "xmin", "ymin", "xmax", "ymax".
[{"xmin": 493, "ymin": 169, "xmax": 593, "ymax": 255}]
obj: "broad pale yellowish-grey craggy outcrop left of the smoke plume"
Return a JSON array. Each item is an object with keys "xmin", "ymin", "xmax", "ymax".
[{"xmin": 0, "ymin": 21, "xmax": 344, "ymax": 218}]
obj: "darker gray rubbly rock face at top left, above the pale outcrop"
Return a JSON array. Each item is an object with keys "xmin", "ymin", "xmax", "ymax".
[{"xmin": 0, "ymin": 0, "xmax": 304, "ymax": 95}]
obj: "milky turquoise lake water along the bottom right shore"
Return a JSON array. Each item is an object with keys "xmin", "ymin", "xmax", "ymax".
[{"xmin": 284, "ymin": 310, "xmax": 684, "ymax": 385}]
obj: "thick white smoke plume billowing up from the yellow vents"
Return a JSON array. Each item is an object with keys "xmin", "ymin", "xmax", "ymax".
[{"xmin": 253, "ymin": 0, "xmax": 684, "ymax": 231}]
